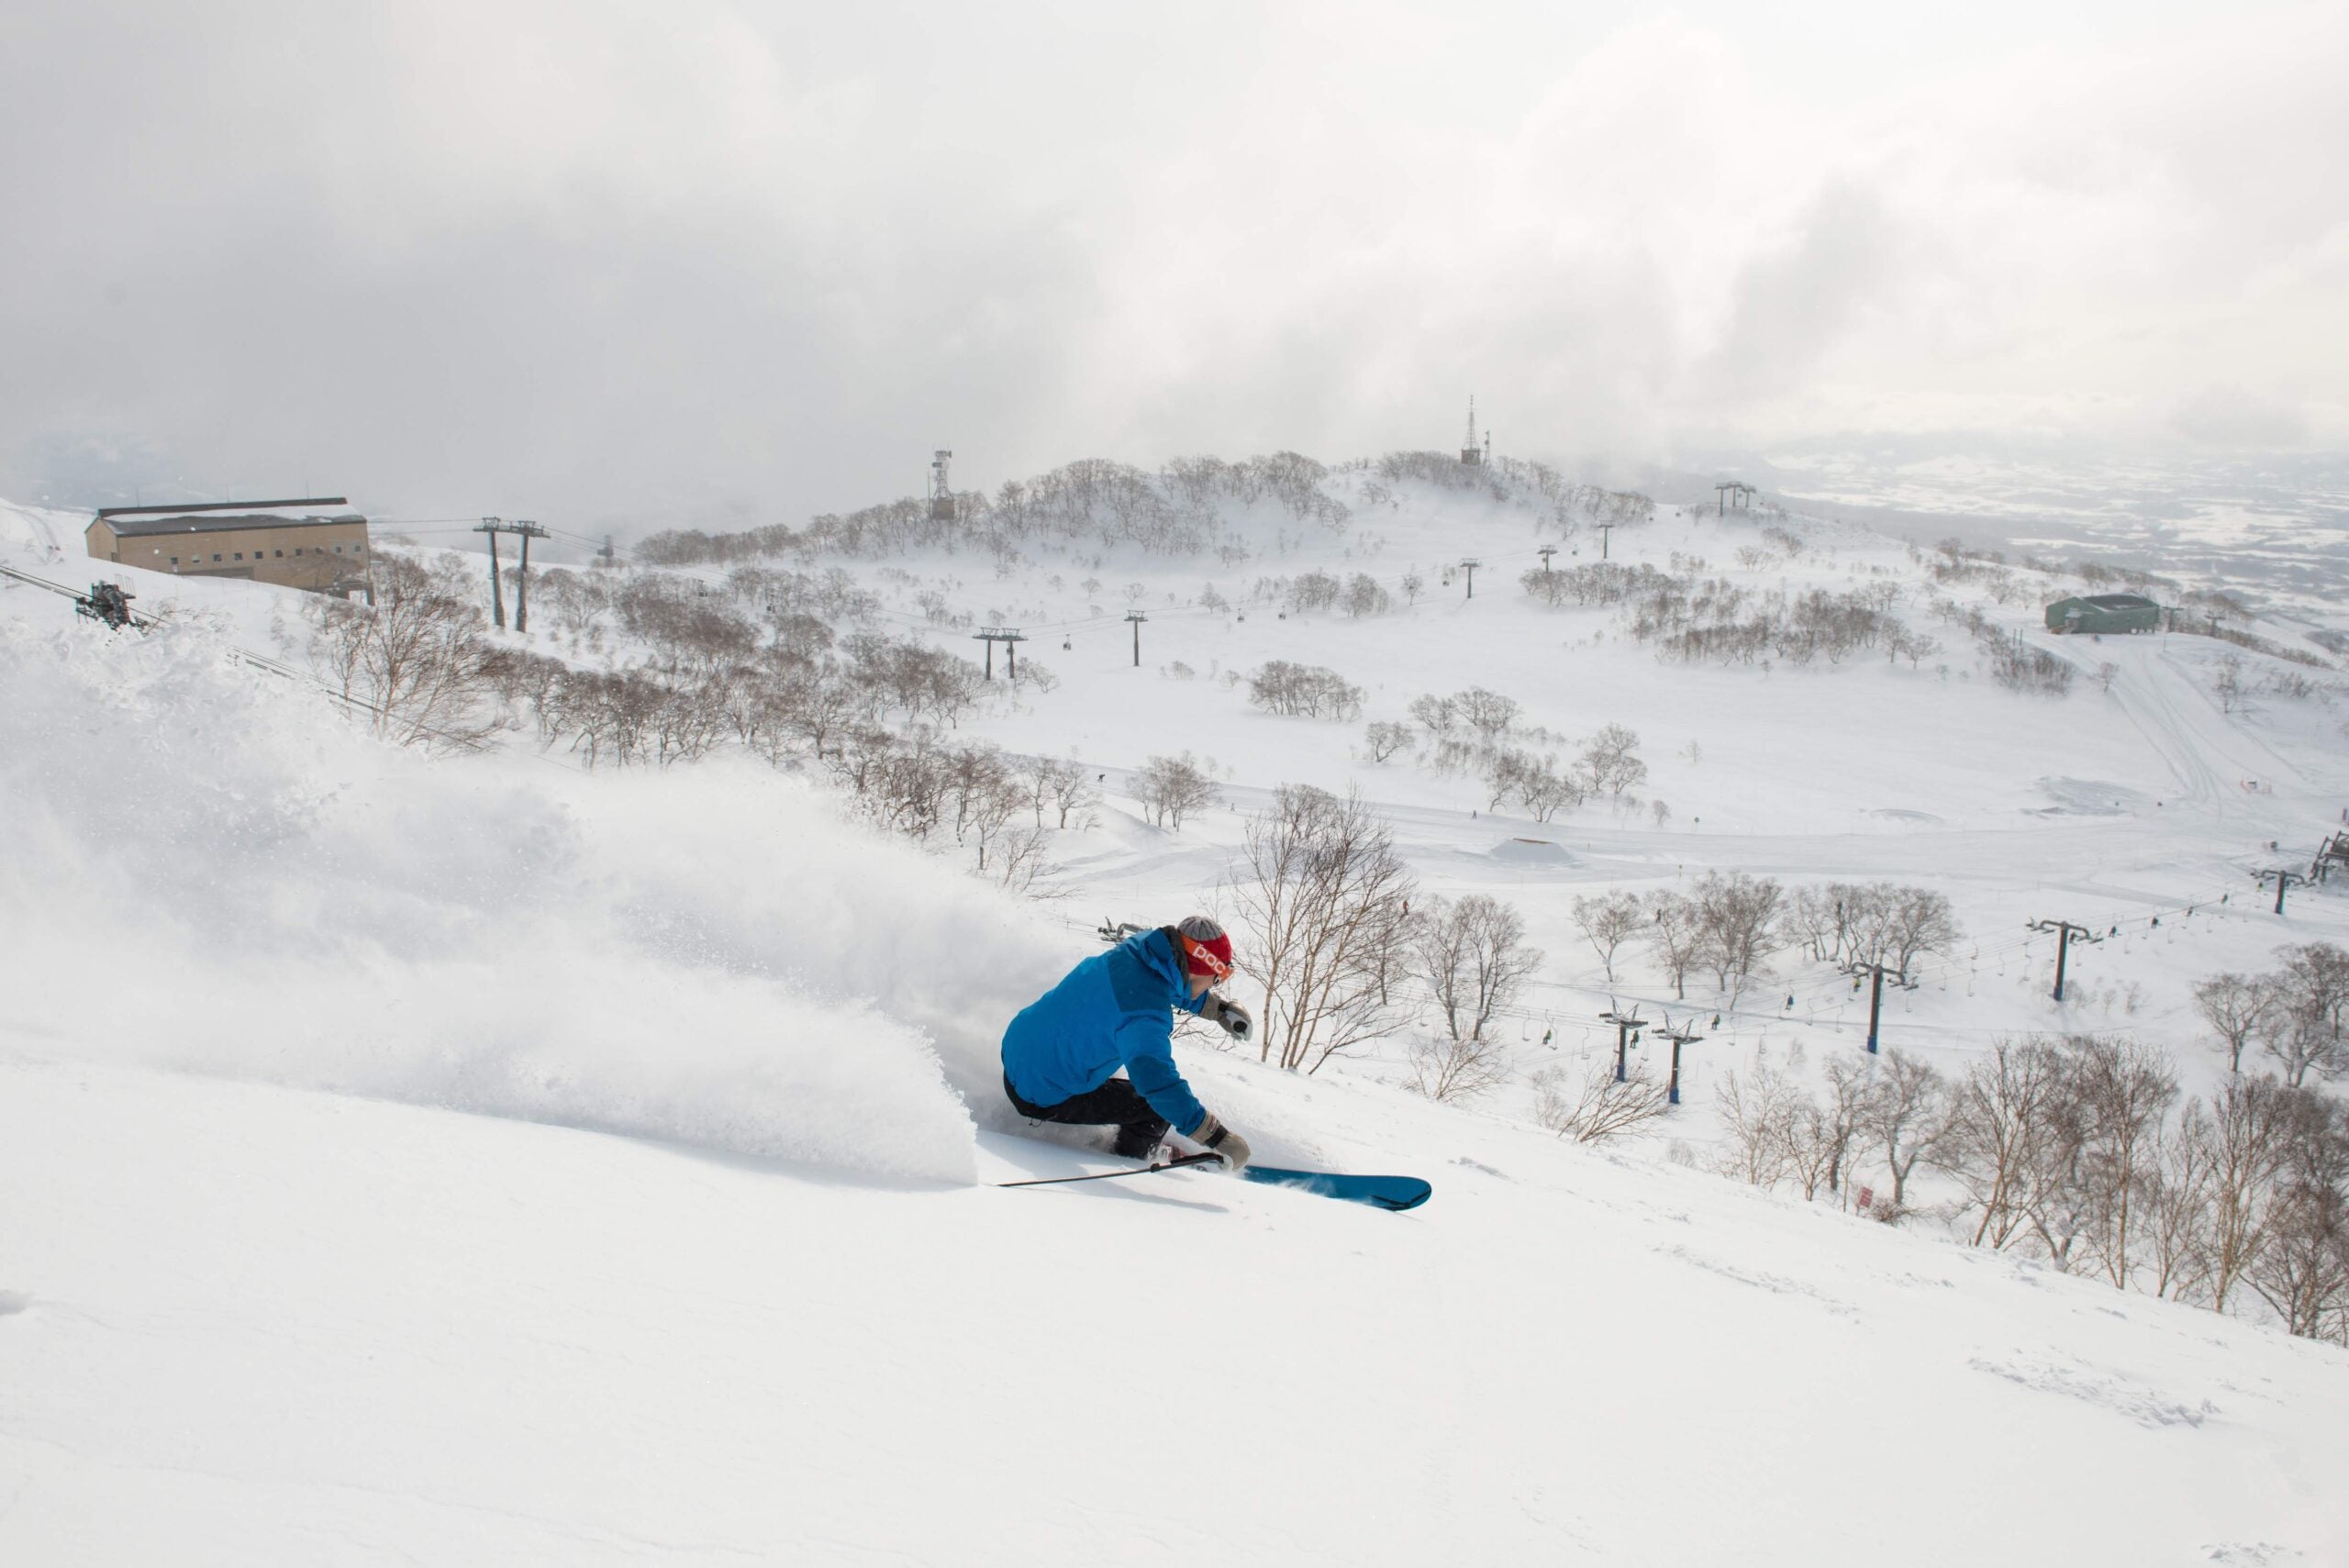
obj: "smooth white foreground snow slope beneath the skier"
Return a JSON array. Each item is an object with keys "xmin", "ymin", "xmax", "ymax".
[{"xmin": 0, "ymin": 1033, "xmax": 2349, "ymax": 1565}]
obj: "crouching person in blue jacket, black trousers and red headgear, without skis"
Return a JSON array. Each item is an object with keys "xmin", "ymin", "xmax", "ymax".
[{"xmin": 1003, "ymin": 916, "xmax": 1252, "ymax": 1172}]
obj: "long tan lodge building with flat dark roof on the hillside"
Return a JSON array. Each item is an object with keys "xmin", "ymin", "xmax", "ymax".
[{"xmin": 89, "ymin": 495, "xmax": 369, "ymax": 594}]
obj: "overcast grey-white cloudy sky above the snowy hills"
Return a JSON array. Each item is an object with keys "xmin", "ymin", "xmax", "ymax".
[{"xmin": 0, "ymin": 0, "xmax": 2349, "ymax": 526}]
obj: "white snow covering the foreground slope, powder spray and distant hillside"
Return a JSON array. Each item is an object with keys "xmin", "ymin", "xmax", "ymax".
[{"xmin": 0, "ymin": 484, "xmax": 2349, "ymax": 1565}]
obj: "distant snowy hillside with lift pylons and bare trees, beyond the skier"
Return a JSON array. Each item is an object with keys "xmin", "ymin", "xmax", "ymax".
[{"xmin": 756, "ymin": 478, "xmax": 2349, "ymax": 1112}]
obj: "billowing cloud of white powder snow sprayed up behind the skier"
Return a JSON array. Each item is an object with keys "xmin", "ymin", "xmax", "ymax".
[{"xmin": 0, "ymin": 619, "xmax": 1060, "ymax": 1181}]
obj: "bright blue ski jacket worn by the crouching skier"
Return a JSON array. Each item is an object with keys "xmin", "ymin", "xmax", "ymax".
[{"xmin": 1003, "ymin": 929, "xmax": 1208, "ymax": 1134}]
